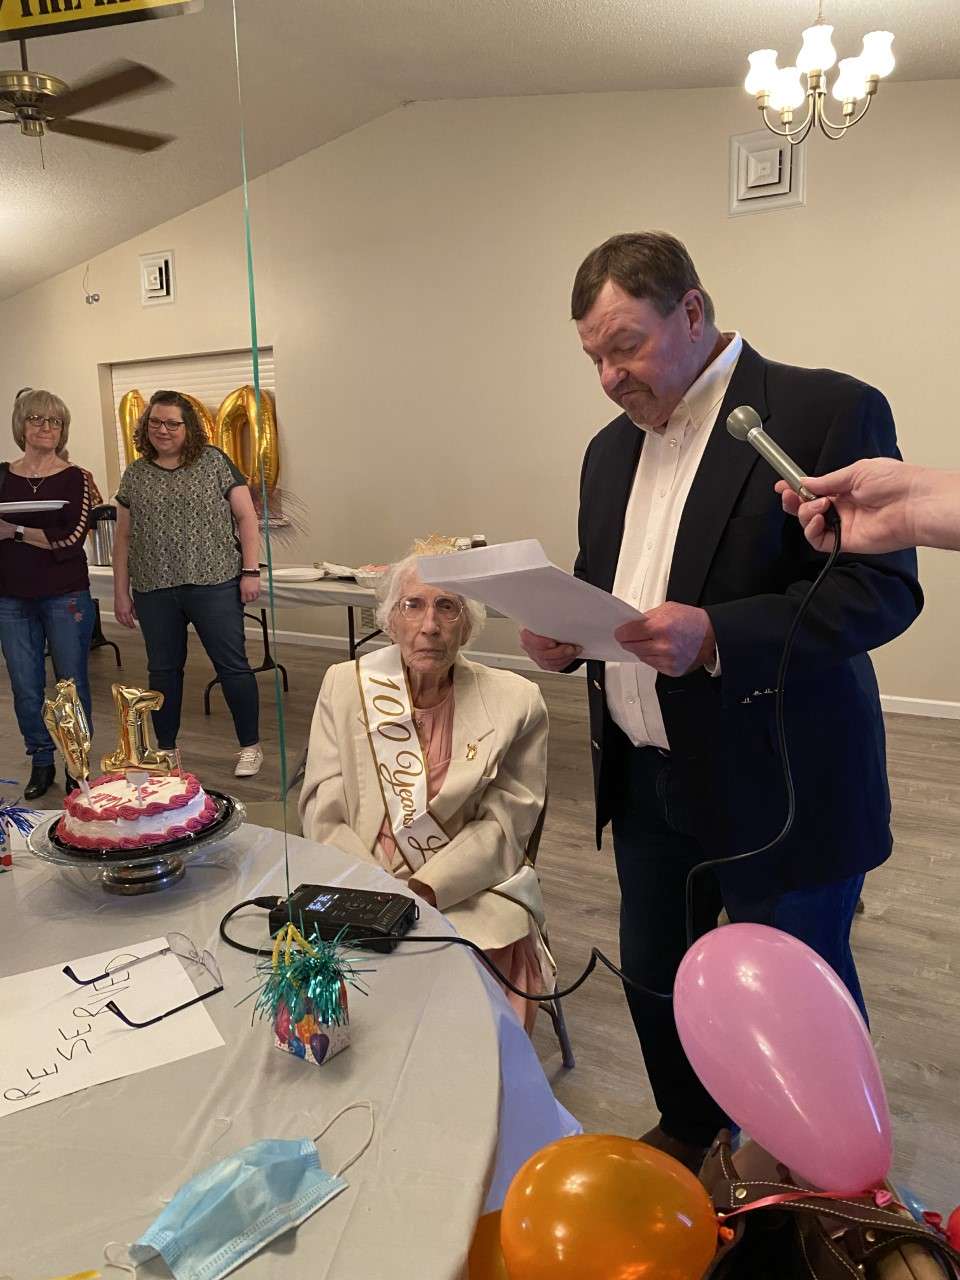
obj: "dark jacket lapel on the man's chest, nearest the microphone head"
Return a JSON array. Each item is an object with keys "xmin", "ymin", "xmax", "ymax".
[{"xmin": 667, "ymin": 343, "xmax": 773, "ymax": 604}]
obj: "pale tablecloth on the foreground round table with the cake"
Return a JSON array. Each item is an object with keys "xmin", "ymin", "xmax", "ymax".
[{"xmin": 0, "ymin": 826, "xmax": 577, "ymax": 1280}]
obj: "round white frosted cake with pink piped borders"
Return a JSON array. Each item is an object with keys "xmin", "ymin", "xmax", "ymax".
[{"xmin": 56, "ymin": 773, "xmax": 216, "ymax": 850}]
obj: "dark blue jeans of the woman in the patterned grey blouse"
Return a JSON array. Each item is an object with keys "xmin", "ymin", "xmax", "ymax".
[{"xmin": 133, "ymin": 577, "xmax": 260, "ymax": 750}]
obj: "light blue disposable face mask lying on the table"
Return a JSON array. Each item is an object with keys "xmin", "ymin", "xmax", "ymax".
[{"xmin": 104, "ymin": 1102, "xmax": 374, "ymax": 1280}]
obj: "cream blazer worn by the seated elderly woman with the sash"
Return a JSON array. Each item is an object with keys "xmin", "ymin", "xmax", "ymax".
[{"xmin": 300, "ymin": 657, "xmax": 547, "ymax": 950}]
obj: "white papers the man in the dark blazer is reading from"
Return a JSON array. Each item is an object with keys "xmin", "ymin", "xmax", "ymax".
[{"xmin": 419, "ymin": 538, "xmax": 643, "ymax": 662}]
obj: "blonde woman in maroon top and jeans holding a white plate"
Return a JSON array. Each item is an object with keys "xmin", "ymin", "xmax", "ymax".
[{"xmin": 0, "ymin": 388, "xmax": 93, "ymax": 800}]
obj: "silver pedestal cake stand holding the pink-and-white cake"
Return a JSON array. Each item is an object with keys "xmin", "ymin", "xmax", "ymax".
[{"xmin": 27, "ymin": 791, "xmax": 247, "ymax": 896}]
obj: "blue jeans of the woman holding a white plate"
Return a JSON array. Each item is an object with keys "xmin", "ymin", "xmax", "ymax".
[{"xmin": 0, "ymin": 591, "xmax": 95, "ymax": 765}]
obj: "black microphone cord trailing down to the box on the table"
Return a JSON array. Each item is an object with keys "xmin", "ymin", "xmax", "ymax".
[{"xmin": 220, "ymin": 507, "xmax": 841, "ymax": 1001}]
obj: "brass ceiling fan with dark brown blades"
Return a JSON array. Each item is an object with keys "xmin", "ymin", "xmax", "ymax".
[{"xmin": 0, "ymin": 41, "xmax": 173, "ymax": 151}]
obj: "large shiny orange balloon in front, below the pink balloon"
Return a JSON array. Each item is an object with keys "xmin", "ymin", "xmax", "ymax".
[{"xmin": 500, "ymin": 1134, "xmax": 717, "ymax": 1280}]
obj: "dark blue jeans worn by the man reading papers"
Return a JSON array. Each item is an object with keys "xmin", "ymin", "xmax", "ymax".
[{"xmin": 612, "ymin": 739, "xmax": 867, "ymax": 1146}]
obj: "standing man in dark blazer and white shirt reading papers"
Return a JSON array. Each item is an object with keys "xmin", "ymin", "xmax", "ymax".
[{"xmin": 521, "ymin": 233, "xmax": 923, "ymax": 1169}]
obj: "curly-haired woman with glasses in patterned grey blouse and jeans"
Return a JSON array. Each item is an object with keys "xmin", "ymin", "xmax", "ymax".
[{"xmin": 114, "ymin": 392, "xmax": 264, "ymax": 778}]
